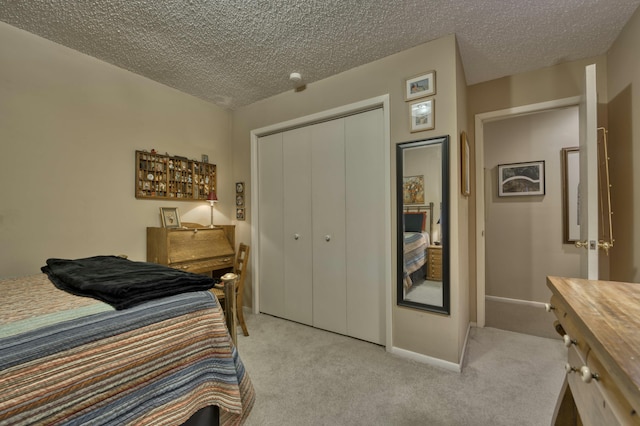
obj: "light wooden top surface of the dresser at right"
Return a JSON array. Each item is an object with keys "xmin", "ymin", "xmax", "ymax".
[{"xmin": 547, "ymin": 277, "xmax": 640, "ymax": 408}]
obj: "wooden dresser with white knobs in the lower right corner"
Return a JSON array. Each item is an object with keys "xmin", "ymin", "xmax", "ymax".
[{"xmin": 547, "ymin": 277, "xmax": 640, "ymax": 426}]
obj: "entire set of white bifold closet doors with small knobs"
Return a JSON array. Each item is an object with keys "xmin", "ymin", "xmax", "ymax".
[{"xmin": 258, "ymin": 109, "xmax": 386, "ymax": 344}]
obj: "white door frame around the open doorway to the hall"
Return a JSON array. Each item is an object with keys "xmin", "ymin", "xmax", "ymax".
[{"xmin": 475, "ymin": 96, "xmax": 581, "ymax": 327}]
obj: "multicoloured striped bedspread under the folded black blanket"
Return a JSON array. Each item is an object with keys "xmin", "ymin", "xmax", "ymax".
[{"xmin": 0, "ymin": 274, "xmax": 255, "ymax": 426}]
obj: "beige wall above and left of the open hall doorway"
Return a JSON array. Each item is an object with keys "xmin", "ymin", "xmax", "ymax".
[{"xmin": 467, "ymin": 56, "xmax": 607, "ymax": 321}]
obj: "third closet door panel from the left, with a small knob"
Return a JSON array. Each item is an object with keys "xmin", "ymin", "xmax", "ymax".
[{"xmin": 311, "ymin": 119, "xmax": 346, "ymax": 334}]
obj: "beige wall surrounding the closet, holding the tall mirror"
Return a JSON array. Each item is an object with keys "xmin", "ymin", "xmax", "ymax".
[{"xmin": 233, "ymin": 36, "xmax": 466, "ymax": 362}]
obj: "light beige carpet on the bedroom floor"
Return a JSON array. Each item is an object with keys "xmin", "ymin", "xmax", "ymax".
[{"xmin": 238, "ymin": 314, "xmax": 566, "ymax": 426}]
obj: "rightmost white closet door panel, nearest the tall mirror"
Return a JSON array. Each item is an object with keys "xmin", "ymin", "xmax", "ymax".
[{"xmin": 345, "ymin": 109, "xmax": 386, "ymax": 344}]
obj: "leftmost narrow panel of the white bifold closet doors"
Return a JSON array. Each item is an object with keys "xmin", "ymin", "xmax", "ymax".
[{"xmin": 258, "ymin": 134, "xmax": 285, "ymax": 317}]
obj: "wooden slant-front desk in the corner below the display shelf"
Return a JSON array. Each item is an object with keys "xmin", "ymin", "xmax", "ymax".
[{"xmin": 147, "ymin": 225, "xmax": 235, "ymax": 274}]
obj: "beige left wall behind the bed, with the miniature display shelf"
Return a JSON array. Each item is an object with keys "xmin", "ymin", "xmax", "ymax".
[{"xmin": 0, "ymin": 22, "xmax": 234, "ymax": 278}]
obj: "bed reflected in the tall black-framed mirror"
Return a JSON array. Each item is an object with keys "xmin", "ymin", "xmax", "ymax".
[{"xmin": 403, "ymin": 203, "xmax": 433, "ymax": 291}]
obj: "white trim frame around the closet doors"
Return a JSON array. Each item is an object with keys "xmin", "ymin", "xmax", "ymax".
[{"xmin": 251, "ymin": 94, "xmax": 393, "ymax": 350}]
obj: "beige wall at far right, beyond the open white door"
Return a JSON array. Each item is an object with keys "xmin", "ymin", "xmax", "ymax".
[{"xmin": 607, "ymin": 5, "xmax": 640, "ymax": 283}]
